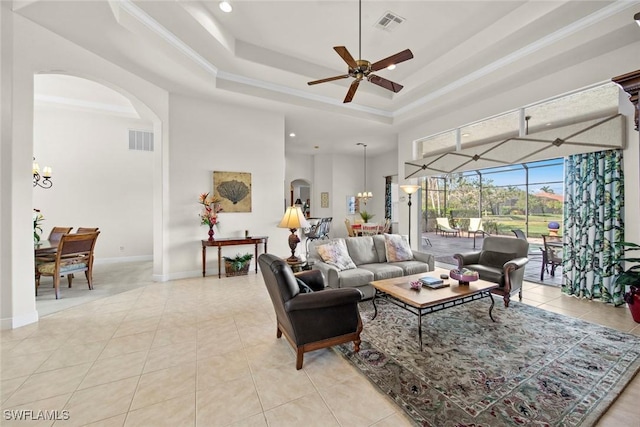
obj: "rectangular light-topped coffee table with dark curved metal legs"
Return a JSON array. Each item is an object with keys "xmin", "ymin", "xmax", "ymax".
[{"xmin": 370, "ymin": 268, "xmax": 498, "ymax": 350}]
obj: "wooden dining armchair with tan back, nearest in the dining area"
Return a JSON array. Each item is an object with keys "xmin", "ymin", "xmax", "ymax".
[{"xmin": 36, "ymin": 231, "xmax": 100, "ymax": 299}]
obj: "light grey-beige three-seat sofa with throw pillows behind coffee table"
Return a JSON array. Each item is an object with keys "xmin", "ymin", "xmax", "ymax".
[{"xmin": 308, "ymin": 234, "xmax": 434, "ymax": 298}]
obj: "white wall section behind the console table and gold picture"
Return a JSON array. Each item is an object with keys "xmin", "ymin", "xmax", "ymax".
[{"xmin": 167, "ymin": 95, "xmax": 290, "ymax": 279}]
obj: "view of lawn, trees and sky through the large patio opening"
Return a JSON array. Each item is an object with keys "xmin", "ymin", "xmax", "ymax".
[{"xmin": 422, "ymin": 159, "xmax": 564, "ymax": 241}]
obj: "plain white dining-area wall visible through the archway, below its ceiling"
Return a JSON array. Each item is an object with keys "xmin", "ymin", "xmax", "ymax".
[{"xmin": 33, "ymin": 106, "xmax": 153, "ymax": 263}]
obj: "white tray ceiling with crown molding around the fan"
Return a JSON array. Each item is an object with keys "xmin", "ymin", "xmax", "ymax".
[{"xmin": 14, "ymin": 0, "xmax": 640, "ymax": 154}]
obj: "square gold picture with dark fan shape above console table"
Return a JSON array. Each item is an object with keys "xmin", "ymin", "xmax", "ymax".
[{"xmin": 213, "ymin": 171, "xmax": 251, "ymax": 213}]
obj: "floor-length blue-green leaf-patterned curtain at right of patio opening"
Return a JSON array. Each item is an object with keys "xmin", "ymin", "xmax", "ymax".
[{"xmin": 562, "ymin": 150, "xmax": 624, "ymax": 305}]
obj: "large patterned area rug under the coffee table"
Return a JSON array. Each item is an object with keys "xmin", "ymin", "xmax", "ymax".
[{"xmin": 335, "ymin": 299, "xmax": 640, "ymax": 427}]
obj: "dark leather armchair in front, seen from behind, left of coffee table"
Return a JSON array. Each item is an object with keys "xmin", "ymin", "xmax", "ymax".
[{"xmin": 258, "ymin": 254, "xmax": 362, "ymax": 369}]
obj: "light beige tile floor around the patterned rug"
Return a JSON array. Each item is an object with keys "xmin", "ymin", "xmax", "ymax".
[{"xmin": 0, "ymin": 263, "xmax": 640, "ymax": 427}]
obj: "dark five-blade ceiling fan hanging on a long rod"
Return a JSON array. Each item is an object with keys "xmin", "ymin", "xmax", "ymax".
[{"xmin": 307, "ymin": 0, "xmax": 413, "ymax": 103}]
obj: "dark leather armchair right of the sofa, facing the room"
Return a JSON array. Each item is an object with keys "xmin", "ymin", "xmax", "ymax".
[{"xmin": 453, "ymin": 236, "xmax": 529, "ymax": 307}]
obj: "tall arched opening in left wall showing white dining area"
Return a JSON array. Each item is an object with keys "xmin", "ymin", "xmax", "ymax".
[{"xmin": 33, "ymin": 74, "xmax": 162, "ymax": 264}]
